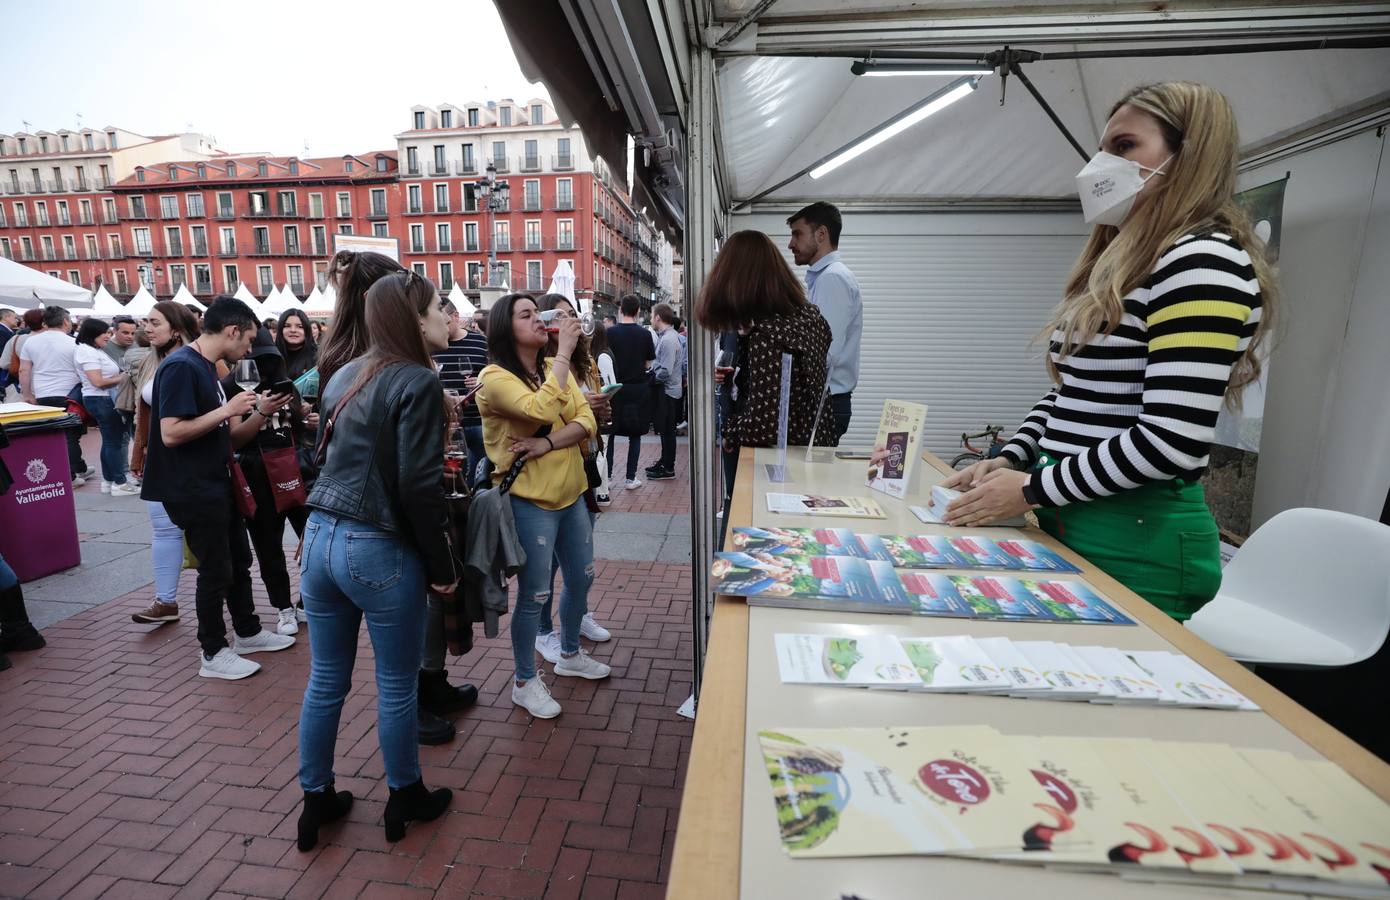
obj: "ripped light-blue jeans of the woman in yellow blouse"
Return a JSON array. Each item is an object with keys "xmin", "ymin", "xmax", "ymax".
[{"xmin": 512, "ymin": 494, "xmax": 594, "ymax": 682}]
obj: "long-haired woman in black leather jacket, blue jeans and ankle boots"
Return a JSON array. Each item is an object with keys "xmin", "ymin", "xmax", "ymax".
[{"xmin": 299, "ymin": 273, "xmax": 457, "ymax": 850}]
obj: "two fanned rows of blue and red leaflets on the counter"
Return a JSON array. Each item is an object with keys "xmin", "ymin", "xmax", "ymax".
[{"xmin": 710, "ymin": 527, "xmax": 1134, "ymax": 625}]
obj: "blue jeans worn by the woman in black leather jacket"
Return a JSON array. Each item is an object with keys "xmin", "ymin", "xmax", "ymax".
[{"xmin": 299, "ymin": 509, "xmax": 428, "ymax": 790}]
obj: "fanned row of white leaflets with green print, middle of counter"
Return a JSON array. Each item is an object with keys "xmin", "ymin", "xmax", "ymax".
[{"xmin": 773, "ymin": 626, "xmax": 1259, "ymax": 709}]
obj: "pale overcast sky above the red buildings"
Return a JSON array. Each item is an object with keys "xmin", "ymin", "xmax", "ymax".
[{"xmin": 0, "ymin": 0, "xmax": 548, "ymax": 156}]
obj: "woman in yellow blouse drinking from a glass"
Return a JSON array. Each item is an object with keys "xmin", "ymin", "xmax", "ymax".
[{"xmin": 478, "ymin": 294, "xmax": 610, "ymax": 719}]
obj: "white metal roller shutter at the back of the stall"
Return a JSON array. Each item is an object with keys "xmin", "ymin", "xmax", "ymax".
[{"xmin": 730, "ymin": 210, "xmax": 1086, "ymax": 459}]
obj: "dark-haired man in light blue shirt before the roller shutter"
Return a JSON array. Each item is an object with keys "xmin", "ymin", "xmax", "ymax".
[{"xmin": 787, "ymin": 200, "xmax": 863, "ymax": 437}]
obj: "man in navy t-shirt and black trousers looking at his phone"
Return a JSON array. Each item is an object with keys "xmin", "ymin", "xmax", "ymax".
[{"xmin": 140, "ymin": 296, "xmax": 295, "ymax": 680}]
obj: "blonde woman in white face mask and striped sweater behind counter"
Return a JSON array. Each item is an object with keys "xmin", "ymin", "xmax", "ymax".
[{"xmin": 945, "ymin": 82, "xmax": 1276, "ymax": 620}]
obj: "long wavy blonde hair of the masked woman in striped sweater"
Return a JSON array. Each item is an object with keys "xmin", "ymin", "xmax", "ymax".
[{"xmin": 1044, "ymin": 81, "xmax": 1277, "ymax": 408}]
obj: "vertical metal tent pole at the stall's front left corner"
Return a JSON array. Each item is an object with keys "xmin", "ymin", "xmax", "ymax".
[{"xmin": 681, "ymin": 45, "xmax": 723, "ymax": 700}]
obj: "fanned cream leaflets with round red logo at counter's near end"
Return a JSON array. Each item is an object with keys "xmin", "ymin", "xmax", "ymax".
[{"xmin": 758, "ymin": 726, "xmax": 1390, "ymax": 897}]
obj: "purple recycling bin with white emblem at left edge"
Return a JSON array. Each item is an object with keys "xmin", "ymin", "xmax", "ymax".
[{"xmin": 0, "ymin": 420, "xmax": 82, "ymax": 581}]
